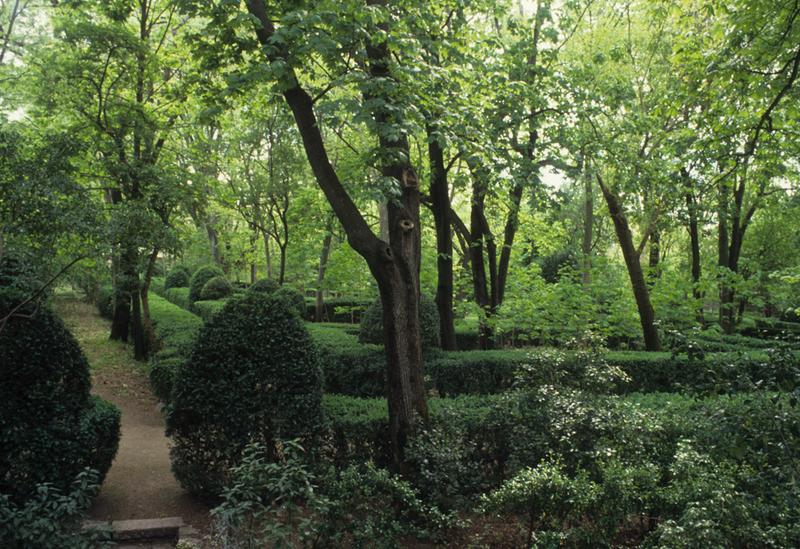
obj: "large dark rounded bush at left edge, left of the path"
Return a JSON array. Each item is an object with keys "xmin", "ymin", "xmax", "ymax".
[{"xmin": 0, "ymin": 289, "xmax": 120, "ymax": 501}]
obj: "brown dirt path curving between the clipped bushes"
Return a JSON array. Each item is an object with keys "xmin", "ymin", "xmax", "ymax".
[{"xmin": 56, "ymin": 297, "xmax": 209, "ymax": 531}]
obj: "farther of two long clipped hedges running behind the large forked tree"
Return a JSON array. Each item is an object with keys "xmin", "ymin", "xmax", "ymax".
[{"xmin": 309, "ymin": 324, "xmax": 800, "ymax": 397}]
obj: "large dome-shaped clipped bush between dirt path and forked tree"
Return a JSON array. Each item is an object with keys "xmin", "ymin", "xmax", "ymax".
[{"xmin": 167, "ymin": 292, "xmax": 325, "ymax": 496}]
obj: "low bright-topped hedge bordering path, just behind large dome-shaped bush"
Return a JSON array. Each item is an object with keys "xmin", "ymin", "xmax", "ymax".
[{"xmin": 150, "ymin": 294, "xmax": 203, "ymax": 402}]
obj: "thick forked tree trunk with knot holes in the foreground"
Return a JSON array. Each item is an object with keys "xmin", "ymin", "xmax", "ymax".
[{"xmin": 246, "ymin": 0, "xmax": 428, "ymax": 471}]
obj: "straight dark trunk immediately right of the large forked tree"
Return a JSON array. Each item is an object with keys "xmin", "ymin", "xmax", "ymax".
[{"xmin": 427, "ymin": 126, "xmax": 457, "ymax": 351}]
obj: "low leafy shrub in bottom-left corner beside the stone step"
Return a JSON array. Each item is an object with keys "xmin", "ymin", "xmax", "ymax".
[{"xmin": 0, "ymin": 469, "xmax": 111, "ymax": 549}]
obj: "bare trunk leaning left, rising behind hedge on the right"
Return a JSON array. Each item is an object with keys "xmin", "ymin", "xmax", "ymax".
[{"xmin": 597, "ymin": 174, "xmax": 661, "ymax": 351}]
